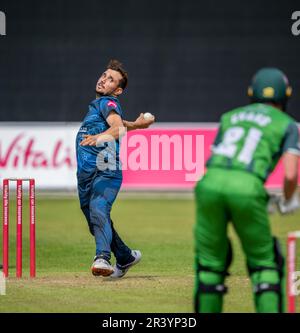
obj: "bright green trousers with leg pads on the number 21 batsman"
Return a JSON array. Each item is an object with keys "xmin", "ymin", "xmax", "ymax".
[{"xmin": 194, "ymin": 168, "xmax": 284, "ymax": 313}]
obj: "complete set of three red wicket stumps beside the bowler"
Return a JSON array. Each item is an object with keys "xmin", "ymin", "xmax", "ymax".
[{"xmin": 2, "ymin": 178, "xmax": 35, "ymax": 278}]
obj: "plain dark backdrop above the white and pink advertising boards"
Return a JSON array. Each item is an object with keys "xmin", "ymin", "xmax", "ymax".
[{"xmin": 0, "ymin": 0, "xmax": 300, "ymax": 122}]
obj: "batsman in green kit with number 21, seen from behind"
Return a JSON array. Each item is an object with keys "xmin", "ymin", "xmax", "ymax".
[{"xmin": 194, "ymin": 68, "xmax": 300, "ymax": 313}]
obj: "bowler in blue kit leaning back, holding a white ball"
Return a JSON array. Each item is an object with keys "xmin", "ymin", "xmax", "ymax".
[{"xmin": 76, "ymin": 60, "xmax": 154, "ymax": 278}]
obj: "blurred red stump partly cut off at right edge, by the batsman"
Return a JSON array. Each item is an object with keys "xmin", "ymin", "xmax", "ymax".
[{"xmin": 287, "ymin": 231, "xmax": 300, "ymax": 313}]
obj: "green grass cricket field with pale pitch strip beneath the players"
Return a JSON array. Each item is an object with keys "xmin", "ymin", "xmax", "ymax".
[{"xmin": 0, "ymin": 197, "xmax": 300, "ymax": 313}]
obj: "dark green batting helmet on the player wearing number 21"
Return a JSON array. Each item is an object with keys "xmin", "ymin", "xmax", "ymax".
[{"xmin": 248, "ymin": 68, "xmax": 292, "ymax": 106}]
